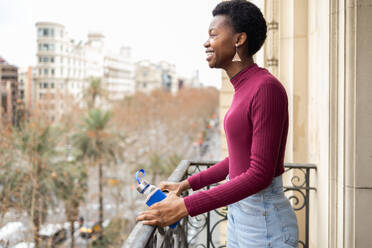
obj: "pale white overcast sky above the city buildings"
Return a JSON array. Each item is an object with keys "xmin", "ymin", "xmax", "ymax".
[{"xmin": 0, "ymin": 0, "xmax": 221, "ymax": 88}]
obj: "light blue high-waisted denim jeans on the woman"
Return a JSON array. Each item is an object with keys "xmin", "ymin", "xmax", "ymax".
[{"xmin": 227, "ymin": 176, "xmax": 298, "ymax": 248}]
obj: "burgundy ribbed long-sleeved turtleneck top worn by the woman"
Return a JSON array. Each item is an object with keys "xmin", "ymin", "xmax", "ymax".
[{"xmin": 184, "ymin": 64, "xmax": 288, "ymax": 216}]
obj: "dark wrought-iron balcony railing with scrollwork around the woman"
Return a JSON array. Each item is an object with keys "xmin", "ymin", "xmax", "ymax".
[{"xmin": 123, "ymin": 160, "xmax": 316, "ymax": 248}]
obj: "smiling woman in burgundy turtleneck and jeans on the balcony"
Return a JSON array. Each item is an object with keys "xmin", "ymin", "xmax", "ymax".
[{"xmin": 137, "ymin": 0, "xmax": 298, "ymax": 248}]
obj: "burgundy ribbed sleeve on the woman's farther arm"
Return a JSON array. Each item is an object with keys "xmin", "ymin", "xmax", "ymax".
[{"xmin": 187, "ymin": 157, "xmax": 229, "ymax": 190}]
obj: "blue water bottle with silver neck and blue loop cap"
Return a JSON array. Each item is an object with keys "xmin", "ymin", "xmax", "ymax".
[{"xmin": 136, "ymin": 169, "xmax": 178, "ymax": 229}]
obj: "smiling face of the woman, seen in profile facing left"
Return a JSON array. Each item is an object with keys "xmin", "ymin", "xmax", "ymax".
[{"xmin": 204, "ymin": 15, "xmax": 235, "ymax": 69}]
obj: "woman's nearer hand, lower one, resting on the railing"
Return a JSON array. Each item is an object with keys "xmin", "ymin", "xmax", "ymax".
[{"xmin": 137, "ymin": 192, "xmax": 189, "ymax": 227}]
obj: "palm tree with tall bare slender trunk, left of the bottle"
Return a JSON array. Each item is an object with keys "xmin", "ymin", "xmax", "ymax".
[{"xmin": 73, "ymin": 109, "xmax": 117, "ymax": 230}]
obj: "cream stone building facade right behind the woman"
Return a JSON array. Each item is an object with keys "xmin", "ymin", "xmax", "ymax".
[{"xmin": 220, "ymin": 0, "xmax": 372, "ymax": 248}]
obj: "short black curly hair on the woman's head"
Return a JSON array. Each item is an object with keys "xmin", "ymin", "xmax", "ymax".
[{"xmin": 212, "ymin": 0, "xmax": 267, "ymax": 56}]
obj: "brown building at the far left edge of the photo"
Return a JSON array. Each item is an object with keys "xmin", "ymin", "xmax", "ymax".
[{"xmin": 0, "ymin": 57, "xmax": 18, "ymax": 125}]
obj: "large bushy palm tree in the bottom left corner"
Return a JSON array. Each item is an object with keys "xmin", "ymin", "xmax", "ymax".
[{"xmin": 0, "ymin": 122, "xmax": 61, "ymax": 248}]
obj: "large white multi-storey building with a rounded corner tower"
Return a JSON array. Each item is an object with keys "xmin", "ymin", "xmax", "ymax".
[{"xmin": 35, "ymin": 22, "xmax": 134, "ymax": 120}]
